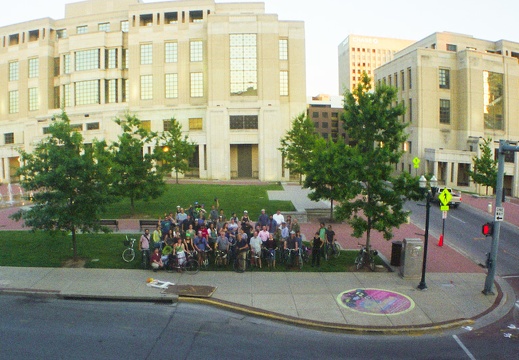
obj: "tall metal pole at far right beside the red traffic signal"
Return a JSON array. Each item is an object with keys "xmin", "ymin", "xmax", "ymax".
[{"xmin": 483, "ymin": 140, "xmax": 519, "ymax": 295}]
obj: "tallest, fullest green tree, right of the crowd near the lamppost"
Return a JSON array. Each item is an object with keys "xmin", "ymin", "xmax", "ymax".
[{"xmin": 308, "ymin": 74, "xmax": 423, "ymax": 263}]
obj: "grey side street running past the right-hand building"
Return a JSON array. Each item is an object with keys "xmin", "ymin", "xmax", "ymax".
[{"xmin": 406, "ymin": 202, "xmax": 519, "ymax": 276}]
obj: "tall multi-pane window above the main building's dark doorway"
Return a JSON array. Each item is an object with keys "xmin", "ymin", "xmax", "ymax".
[{"xmin": 229, "ymin": 34, "xmax": 258, "ymax": 96}]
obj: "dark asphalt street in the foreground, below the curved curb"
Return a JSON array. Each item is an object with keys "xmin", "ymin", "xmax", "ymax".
[{"xmin": 0, "ymin": 296, "xmax": 519, "ymax": 360}]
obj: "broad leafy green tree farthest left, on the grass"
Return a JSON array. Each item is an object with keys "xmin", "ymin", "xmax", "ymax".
[{"xmin": 12, "ymin": 112, "xmax": 112, "ymax": 259}]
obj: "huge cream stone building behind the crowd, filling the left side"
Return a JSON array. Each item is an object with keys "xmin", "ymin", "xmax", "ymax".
[{"xmin": 0, "ymin": 0, "xmax": 306, "ymax": 182}]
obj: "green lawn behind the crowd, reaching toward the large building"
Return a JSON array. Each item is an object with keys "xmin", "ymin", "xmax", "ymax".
[{"xmin": 102, "ymin": 184, "xmax": 295, "ymax": 220}]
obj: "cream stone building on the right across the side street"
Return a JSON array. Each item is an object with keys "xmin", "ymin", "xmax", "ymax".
[{"xmin": 375, "ymin": 32, "xmax": 519, "ymax": 196}]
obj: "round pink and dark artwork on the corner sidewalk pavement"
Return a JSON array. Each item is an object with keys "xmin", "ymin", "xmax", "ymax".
[{"xmin": 337, "ymin": 289, "xmax": 415, "ymax": 315}]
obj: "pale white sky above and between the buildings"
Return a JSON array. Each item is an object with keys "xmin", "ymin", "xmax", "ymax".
[{"xmin": 0, "ymin": 0, "xmax": 519, "ymax": 96}]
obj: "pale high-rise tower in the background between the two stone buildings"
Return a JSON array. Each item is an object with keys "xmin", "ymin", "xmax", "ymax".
[{"xmin": 338, "ymin": 35, "xmax": 414, "ymax": 94}]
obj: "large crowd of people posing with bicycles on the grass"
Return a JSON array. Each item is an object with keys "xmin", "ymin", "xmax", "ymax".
[{"xmin": 139, "ymin": 198, "xmax": 335, "ymax": 271}]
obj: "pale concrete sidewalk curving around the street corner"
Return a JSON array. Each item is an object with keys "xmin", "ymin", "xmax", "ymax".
[{"xmin": 0, "ymin": 267, "xmax": 506, "ymax": 333}]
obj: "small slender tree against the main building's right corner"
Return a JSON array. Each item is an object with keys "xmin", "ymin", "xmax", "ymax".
[{"xmin": 279, "ymin": 113, "xmax": 319, "ymax": 182}]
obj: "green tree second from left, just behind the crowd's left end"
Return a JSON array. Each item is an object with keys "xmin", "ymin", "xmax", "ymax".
[{"xmin": 111, "ymin": 114, "xmax": 165, "ymax": 213}]
